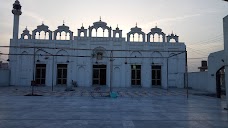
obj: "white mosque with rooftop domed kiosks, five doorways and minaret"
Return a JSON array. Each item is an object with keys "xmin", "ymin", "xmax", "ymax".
[{"xmin": 9, "ymin": 0, "xmax": 187, "ymax": 89}]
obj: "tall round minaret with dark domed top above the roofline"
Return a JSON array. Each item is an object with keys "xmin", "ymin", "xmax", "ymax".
[{"xmin": 12, "ymin": 0, "xmax": 22, "ymax": 39}]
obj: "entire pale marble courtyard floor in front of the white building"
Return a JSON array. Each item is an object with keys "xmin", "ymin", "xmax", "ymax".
[{"xmin": 0, "ymin": 87, "xmax": 228, "ymax": 128}]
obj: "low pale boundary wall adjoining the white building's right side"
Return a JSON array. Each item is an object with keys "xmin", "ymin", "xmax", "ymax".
[{"xmin": 188, "ymin": 72, "xmax": 208, "ymax": 91}]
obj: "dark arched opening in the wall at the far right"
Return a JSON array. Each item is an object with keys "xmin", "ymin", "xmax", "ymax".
[{"xmin": 216, "ymin": 66, "xmax": 226, "ymax": 98}]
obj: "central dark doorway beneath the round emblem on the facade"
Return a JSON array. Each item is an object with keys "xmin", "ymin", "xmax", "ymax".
[{"xmin": 93, "ymin": 65, "xmax": 107, "ymax": 85}]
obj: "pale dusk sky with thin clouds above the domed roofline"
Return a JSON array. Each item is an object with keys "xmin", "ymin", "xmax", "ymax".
[{"xmin": 0, "ymin": 0, "xmax": 228, "ymax": 72}]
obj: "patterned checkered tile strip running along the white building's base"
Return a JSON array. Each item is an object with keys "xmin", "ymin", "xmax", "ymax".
[{"xmin": 0, "ymin": 86, "xmax": 187, "ymax": 97}]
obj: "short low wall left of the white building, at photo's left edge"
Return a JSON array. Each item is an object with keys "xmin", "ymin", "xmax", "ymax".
[{"xmin": 0, "ymin": 69, "xmax": 10, "ymax": 86}]
